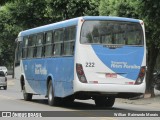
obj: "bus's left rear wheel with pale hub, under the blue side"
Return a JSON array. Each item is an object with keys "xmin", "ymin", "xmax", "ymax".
[{"xmin": 47, "ymin": 81, "xmax": 61, "ymax": 106}]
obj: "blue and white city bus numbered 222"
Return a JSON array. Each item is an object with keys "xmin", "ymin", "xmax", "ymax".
[{"xmin": 15, "ymin": 16, "xmax": 146, "ymax": 107}]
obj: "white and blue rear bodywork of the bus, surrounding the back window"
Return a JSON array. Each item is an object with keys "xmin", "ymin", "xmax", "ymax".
[{"xmin": 74, "ymin": 17, "xmax": 146, "ymax": 95}]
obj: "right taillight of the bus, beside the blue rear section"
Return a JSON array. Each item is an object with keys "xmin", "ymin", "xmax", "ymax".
[{"xmin": 135, "ymin": 66, "xmax": 146, "ymax": 85}]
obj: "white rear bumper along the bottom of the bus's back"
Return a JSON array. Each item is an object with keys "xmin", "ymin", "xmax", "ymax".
[{"xmin": 75, "ymin": 81, "xmax": 146, "ymax": 93}]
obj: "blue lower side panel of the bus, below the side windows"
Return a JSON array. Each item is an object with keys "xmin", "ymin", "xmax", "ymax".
[{"xmin": 23, "ymin": 57, "xmax": 74, "ymax": 97}]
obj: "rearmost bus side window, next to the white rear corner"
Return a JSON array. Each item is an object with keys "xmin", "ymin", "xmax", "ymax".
[{"xmin": 63, "ymin": 26, "xmax": 76, "ymax": 56}]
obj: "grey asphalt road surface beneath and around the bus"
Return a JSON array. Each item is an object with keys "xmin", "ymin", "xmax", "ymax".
[{"xmin": 0, "ymin": 76, "xmax": 160, "ymax": 120}]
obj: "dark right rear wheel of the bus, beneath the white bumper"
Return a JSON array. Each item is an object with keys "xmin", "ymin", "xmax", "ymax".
[{"xmin": 94, "ymin": 97, "xmax": 115, "ymax": 107}]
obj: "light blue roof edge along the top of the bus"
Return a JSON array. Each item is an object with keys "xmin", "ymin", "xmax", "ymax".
[{"xmin": 18, "ymin": 16, "xmax": 140, "ymax": 36}]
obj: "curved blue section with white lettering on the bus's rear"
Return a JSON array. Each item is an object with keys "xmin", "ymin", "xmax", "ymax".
[{"xmin": 92, "ymin": 45, "xmax": 144, "ymax": 81}]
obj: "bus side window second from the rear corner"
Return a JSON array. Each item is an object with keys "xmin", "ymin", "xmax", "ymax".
[{"xmin": 54, "ymin": 29, "xmax": 64, "ymax": 56}]
